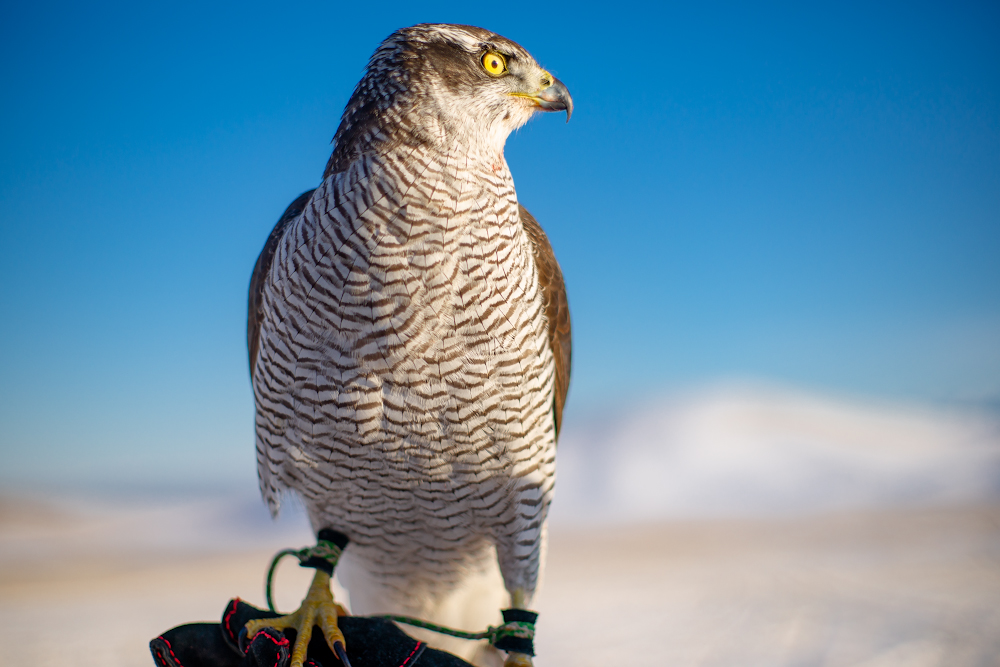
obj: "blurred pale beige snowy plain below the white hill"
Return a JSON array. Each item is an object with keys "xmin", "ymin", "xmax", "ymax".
[{"xmin": 0, "ymin": 506, "xmax": 1000, "ymax": 667}]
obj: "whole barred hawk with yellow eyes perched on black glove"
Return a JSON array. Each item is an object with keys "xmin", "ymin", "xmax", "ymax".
[{"xmin": 248, "ymin": 24, "xmax": 573, "ymax": 667}]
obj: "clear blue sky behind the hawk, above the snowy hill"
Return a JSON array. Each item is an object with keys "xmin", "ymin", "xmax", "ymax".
[{"xmin": 0, "ymin": 2, "xmax": 1000, "ymax": 484}]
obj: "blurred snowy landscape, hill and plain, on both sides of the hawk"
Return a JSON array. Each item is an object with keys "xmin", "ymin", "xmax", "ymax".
[{"xmin": 0, "ymin": 391, "xmax": 1000, "ymax": 667}]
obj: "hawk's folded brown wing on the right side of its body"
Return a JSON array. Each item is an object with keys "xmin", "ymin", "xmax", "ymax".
[{"xmin": 518, "ymin": 204, "xmax": 573, "ymax": 436}]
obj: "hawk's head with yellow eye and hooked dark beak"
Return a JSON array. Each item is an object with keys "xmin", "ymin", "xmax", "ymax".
[{"xmin": 327, "ymin": 24, "xmax": 573, "ymax": 173}]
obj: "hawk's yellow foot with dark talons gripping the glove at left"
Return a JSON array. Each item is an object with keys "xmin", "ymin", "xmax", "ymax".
[{"xmin": 246, "ymin": 570, "xmax": 350, "ymax": 667}]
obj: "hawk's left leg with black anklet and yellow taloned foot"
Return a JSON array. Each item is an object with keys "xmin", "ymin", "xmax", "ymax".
[{"xmin": 245, "ymin": 531, "xmax": 351, "ymax": 667}]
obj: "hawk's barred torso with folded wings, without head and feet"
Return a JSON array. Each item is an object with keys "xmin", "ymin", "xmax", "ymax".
[{"xmin": 248, "ymin": 144, "xmax": 569, "ymax": 624}]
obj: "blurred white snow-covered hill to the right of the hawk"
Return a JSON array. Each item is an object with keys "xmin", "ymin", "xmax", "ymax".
[{"xmin": 552, "ymin": 385, "xmax": 1000, "ymax": 525}]
